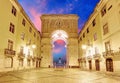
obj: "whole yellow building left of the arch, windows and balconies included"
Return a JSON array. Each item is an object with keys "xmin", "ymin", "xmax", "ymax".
[{"xmin": 0, "ymin": 0, "xmax": 41, "ymax": 71}]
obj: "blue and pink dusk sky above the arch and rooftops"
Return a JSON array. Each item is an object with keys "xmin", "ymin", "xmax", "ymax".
[{"xmin": 18, "ymin": 0, "xmax": 99, "ymax": 31}]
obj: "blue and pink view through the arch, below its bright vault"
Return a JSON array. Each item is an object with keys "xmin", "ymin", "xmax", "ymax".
[{"xmin": 53, "ymin": 39, "xmax": 67, "ymax": 67}]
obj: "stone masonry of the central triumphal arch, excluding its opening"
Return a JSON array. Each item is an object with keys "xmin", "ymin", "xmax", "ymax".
[{"xmin": 41, "ymin": 14, "xmax": 78, "ymax": 67}]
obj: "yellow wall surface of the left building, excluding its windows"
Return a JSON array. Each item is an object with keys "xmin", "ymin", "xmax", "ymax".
[{"xmin": 0, "ymin": 0, "xmax": 41, "ymax": 71}]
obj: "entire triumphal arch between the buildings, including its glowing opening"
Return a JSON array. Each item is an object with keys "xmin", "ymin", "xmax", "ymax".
[{"xmin": 41, "ymin": 14, "xmax": 78, "ymax": 67}]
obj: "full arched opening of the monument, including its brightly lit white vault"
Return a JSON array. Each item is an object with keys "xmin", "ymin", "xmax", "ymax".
[{"xmin": 51, "ymin": 30, "xmax": 68, "ymax": 67}]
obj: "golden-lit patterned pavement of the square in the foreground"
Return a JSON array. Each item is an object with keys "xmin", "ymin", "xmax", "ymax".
[{"xmin": 0, "ymin": 68, "xmax": 120, "ymax": 83}]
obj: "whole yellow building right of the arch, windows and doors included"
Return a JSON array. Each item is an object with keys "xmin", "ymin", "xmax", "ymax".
[{"xmin": 78, "ymin": 0, "xmax": 120, "ymax": 72}]
